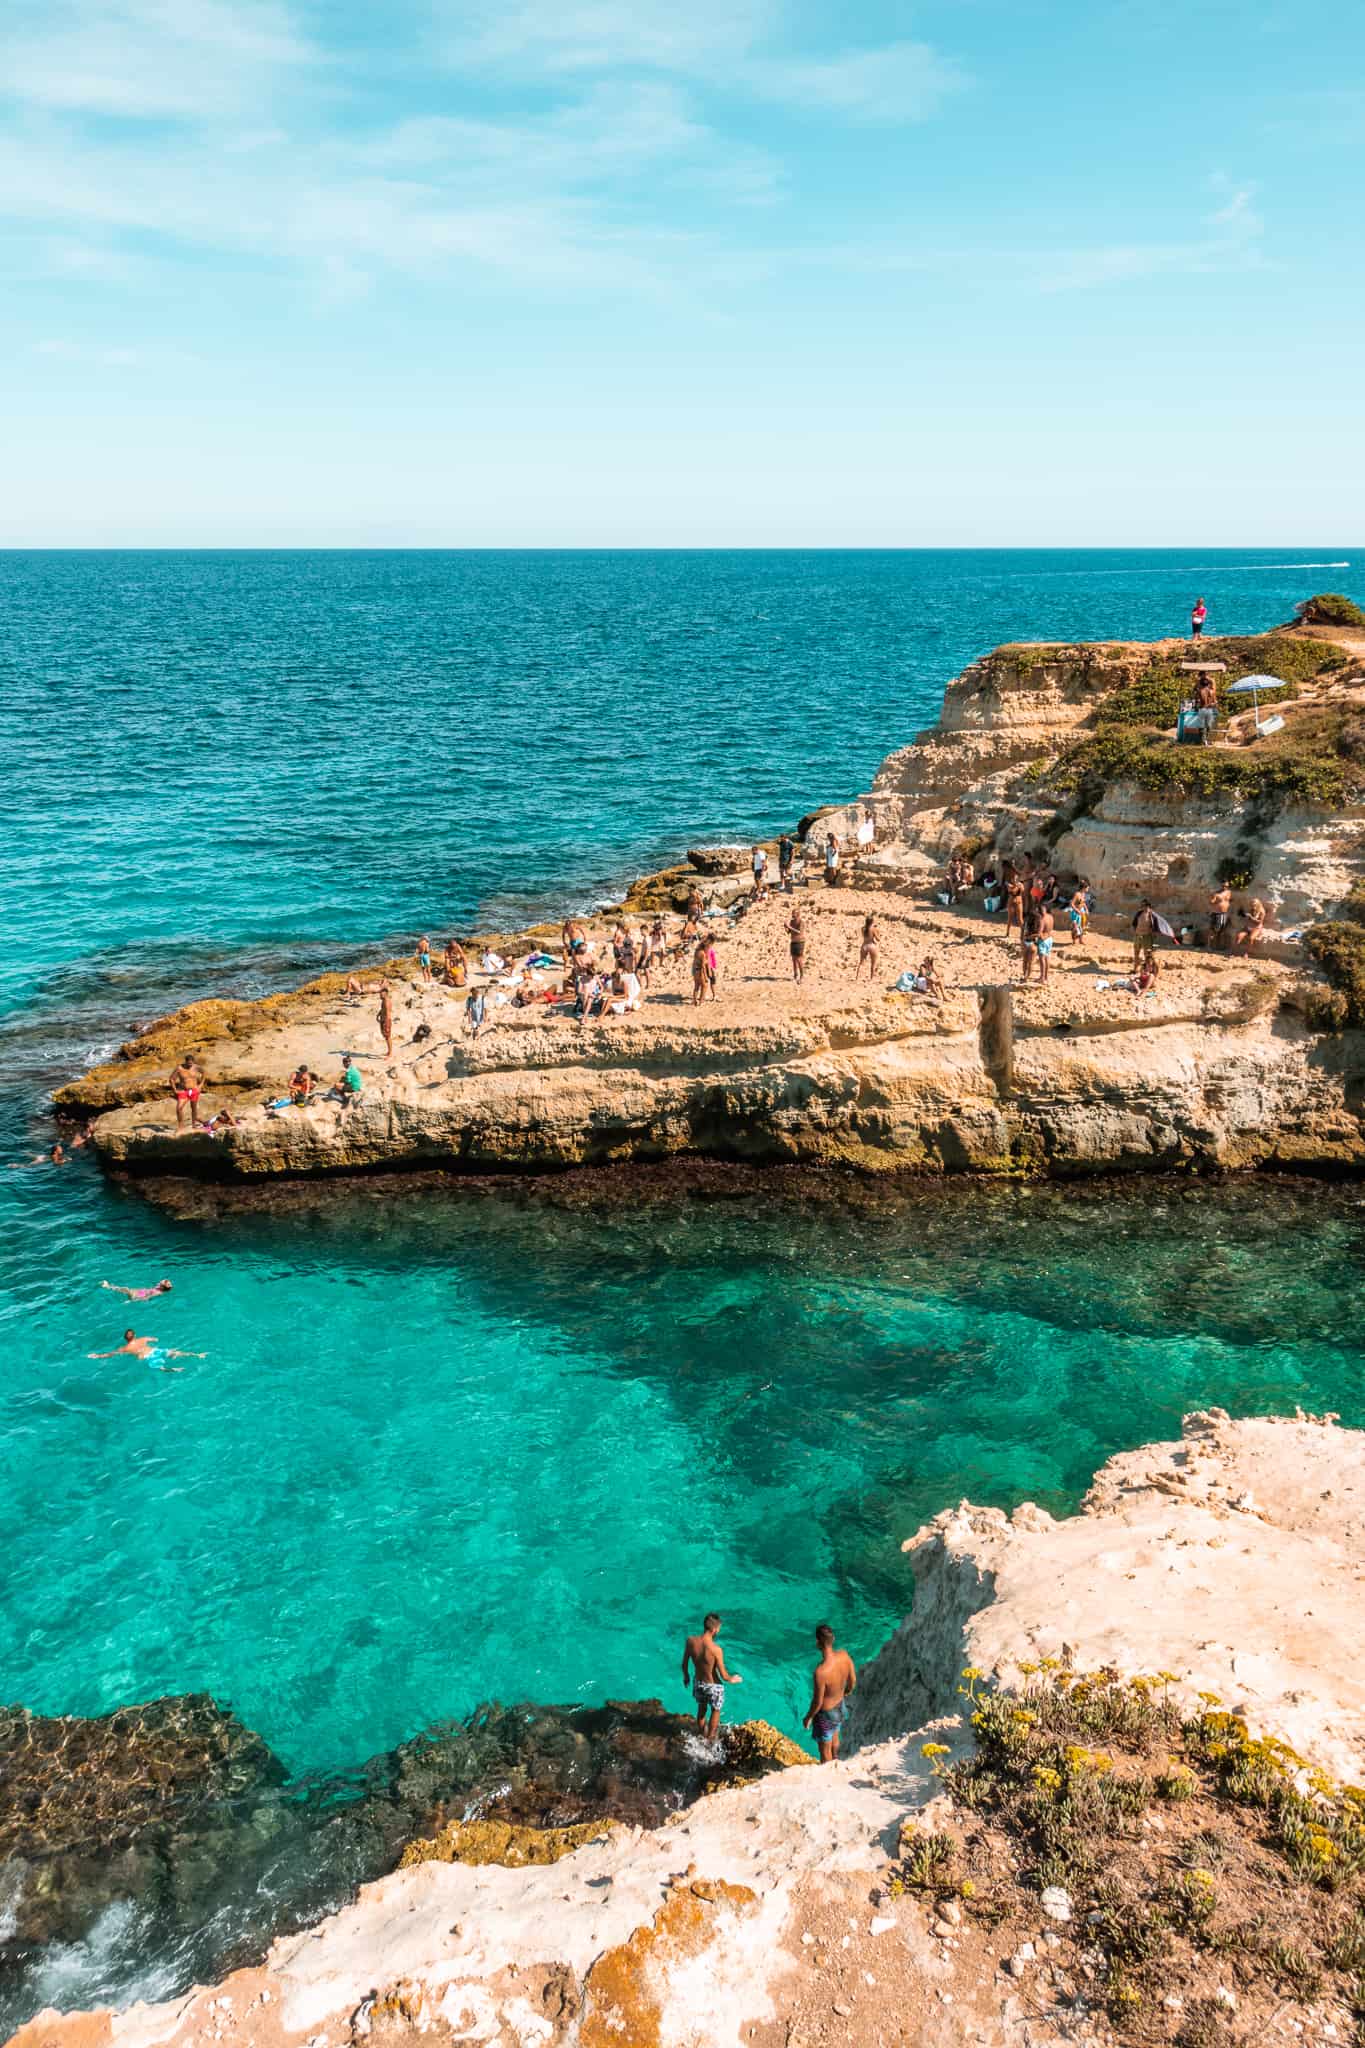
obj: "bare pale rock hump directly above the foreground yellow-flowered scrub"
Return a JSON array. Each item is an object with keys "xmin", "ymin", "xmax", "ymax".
[{"xmin": 853, "ymin": 1409, "xmax": 1365, "ymax": 1782}]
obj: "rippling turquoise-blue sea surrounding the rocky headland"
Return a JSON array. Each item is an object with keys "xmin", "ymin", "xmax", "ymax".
[{"xmin": 0, "ymin": 547, "xmax": 1365, "ymax": 2003}]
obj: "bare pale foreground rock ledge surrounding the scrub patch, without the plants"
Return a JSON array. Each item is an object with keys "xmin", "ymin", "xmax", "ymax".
[{"xmin": 16, "ymin": 1411, "xmax": 1365, "ymax": 2048}]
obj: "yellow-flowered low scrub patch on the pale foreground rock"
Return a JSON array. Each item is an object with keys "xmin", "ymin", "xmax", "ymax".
[{"xmin": 886, "ymin": 1659, "xmax": 1365, "ymax": 2048}]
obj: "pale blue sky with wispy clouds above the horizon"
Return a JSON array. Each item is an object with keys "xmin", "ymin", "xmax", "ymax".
[{"xmin": 0, "ymin": 0, "xmax": 1365, "ymax": 547}]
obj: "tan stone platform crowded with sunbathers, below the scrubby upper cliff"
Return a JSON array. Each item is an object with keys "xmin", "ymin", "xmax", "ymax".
[{"xmin": 50, "ymin": 885, "xmax": 1365, "ymax": 1180}]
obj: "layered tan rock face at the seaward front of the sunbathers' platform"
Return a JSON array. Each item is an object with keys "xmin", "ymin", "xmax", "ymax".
[{"xmin": 56, "ymin": 948, "xmax": 1365, "ymax": 1180}]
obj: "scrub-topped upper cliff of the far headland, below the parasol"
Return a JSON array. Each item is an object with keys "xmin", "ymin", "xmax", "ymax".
[{"xmin": 855, "ymin": 631, "xmax": 1365, "ymax": 926}]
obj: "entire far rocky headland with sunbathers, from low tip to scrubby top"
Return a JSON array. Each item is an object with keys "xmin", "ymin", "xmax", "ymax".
[{"xmin": 55, "ymin": 629, "xmax": 1365, "ymax": 1182}]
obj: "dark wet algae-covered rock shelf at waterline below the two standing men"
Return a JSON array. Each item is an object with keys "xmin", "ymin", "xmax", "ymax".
[{"xmin": 0, "ymin": 1694, "xmax": 810, "ymax": 2028}]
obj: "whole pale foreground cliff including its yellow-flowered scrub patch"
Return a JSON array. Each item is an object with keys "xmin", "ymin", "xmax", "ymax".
[{"xmin": 16, "ymin": 1409, "xmax": 1365, "ymax": 2048}]
